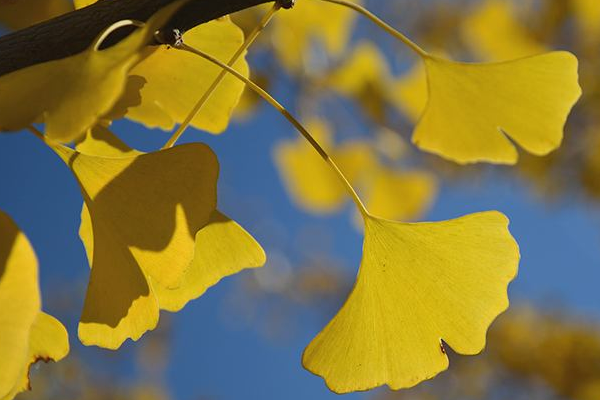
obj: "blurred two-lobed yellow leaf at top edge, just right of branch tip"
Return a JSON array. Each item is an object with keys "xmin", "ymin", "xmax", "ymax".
[{"xmin": 272, "ymin": 0, "xmax": 360, "ymax": 72}]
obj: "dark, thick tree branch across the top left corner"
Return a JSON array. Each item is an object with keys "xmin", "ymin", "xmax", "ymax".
[{"xmin": 0, "ymin": 0, "xmax": 272, "ymax": 76}]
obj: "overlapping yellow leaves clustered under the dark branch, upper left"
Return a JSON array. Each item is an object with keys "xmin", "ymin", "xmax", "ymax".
[{"xmin": 0, "ymin": 1, "xmax": 248, "ymax": 143}]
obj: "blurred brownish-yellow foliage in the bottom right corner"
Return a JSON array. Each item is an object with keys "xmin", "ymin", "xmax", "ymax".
[{"xmin": 490, "ymin": 307, "xmax": 600, "ymax": 400}]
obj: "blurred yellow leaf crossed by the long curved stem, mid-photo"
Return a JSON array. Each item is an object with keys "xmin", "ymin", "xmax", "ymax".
[{"xmin": 275, "ymin": 119, "xmax": 375, "ymax": 213}]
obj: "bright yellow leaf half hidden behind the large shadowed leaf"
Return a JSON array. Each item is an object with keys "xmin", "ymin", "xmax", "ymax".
[{"xmin": 154, "ymin": 211, "xmax": 266, "ymax": 311}]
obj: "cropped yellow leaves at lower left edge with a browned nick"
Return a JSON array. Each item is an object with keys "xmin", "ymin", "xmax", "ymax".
[{"xmin": 0, "ymin": 211, "xmax": 69, "ymax": 400}]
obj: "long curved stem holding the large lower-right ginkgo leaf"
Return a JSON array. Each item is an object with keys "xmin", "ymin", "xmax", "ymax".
[{"xmin": 177, "ymin": 43, "xmax": 370, "ymax": 218}]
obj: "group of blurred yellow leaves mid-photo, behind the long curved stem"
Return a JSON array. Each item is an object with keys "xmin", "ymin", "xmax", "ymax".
[{"xmin": 275, "ymin": 119, "xmax": 437, "ymax": 220}]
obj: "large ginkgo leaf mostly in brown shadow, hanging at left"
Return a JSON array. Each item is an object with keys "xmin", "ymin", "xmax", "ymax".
[{"xmin": 53, "ymin": 140, "xmax": 218, "ymax": 349}]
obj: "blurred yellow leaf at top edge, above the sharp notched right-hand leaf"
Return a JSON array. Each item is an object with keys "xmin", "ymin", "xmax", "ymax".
[{"xmin": 462, "ymin": 0, "xmax": 548, "ymax": 61}]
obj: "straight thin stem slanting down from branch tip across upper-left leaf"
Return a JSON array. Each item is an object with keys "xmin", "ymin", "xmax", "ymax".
[{"xmin": 162, "ymin": 2, "xmax": 281, "ymax": 150}]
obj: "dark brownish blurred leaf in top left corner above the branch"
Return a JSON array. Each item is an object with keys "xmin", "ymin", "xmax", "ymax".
[{"xmin": 0, "ymin": 0, "xmax": 73, "ymax": 30}]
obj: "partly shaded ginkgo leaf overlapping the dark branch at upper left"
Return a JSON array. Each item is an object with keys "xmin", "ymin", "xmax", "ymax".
[{"xmin": 0, "ymin": 1, "xmax": 182, "ymax": 142}]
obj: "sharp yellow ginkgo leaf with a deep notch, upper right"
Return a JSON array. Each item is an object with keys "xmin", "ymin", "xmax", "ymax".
[{"xmin": 413, "ymin": 52, "xmax": 581, "ymax": 164}]
